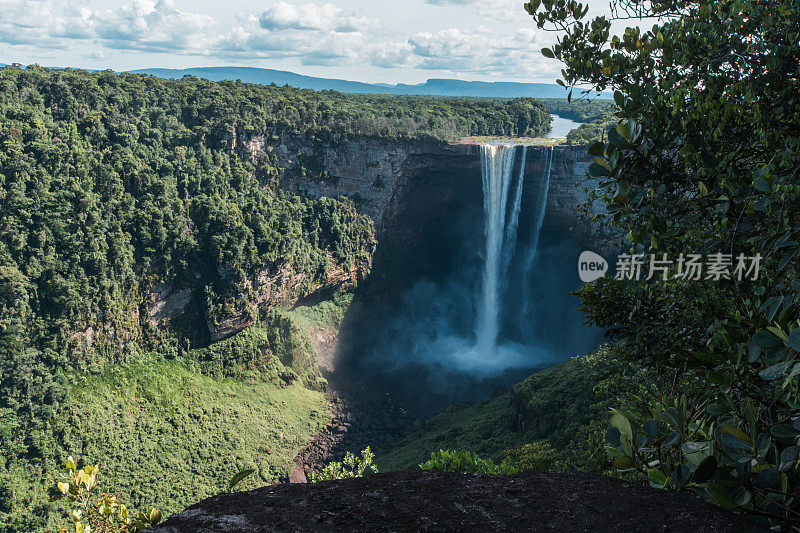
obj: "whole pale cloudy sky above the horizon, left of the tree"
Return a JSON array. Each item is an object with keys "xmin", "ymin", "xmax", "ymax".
[{"xmin": 0, "ymin": 0, "xmax": 608, "ymax": 83}]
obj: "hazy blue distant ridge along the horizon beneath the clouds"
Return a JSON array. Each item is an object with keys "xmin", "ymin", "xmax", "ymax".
[{"xmin": 131, "ymin": 67, "xmax": 608, "ymax": 98}]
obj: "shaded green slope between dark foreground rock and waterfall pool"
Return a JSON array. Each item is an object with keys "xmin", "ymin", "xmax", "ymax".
[{"xmin": 376, "ymin": 356, "xmax": 604, "ymax": 470}]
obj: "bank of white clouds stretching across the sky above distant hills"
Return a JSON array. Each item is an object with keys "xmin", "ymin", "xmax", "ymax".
[{"xmin": 0, "ymin": 0, "xmax": 557, "ymax": 78}]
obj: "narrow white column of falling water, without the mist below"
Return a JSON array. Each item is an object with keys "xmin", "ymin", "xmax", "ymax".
[{"xmin": 475, "ymin": 144, "xmax": 525, "ymax": 353}]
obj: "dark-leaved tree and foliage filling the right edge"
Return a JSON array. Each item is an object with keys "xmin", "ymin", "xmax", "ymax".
[{"xmin": 525, "ymin": 0, "xmax": 800, "ymax": 524}]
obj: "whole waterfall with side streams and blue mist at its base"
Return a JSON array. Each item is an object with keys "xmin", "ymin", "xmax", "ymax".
[{"xmin": 366, "ymin": 143, "xmax": 561, "ymax": 380}]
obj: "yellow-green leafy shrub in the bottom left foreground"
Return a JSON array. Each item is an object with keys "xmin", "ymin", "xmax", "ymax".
[{"xmin": 50, "ymin": 457, "xmax": 162, "ymax": 533}]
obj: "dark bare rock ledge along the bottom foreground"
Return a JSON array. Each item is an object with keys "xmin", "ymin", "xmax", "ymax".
[{"xmin": 149, "ymin": 470, "xmax": 764, "ymax": 533}]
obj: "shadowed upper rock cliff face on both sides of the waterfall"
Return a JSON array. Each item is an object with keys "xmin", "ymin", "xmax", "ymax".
[{"xmin": 253, "ymin": 136, "xmax": 597, "ymax": 241}]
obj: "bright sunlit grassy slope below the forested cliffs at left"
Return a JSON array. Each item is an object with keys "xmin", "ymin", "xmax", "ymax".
[{"xmin": 10, "ymin": 361, "xmax": 330, "ymax": 525}]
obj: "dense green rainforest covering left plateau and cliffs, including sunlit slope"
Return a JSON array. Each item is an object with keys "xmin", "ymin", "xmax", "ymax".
[{"xmin": 0, "ymin": 66, "xmax": 550, "ymax": 531}]
